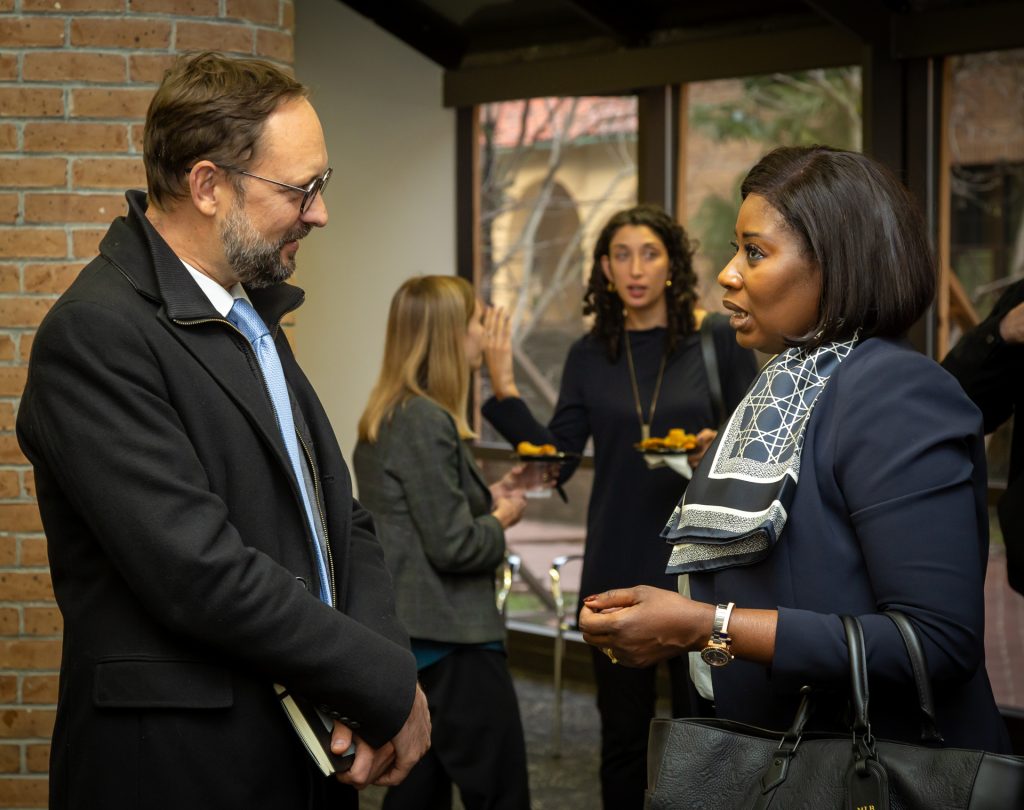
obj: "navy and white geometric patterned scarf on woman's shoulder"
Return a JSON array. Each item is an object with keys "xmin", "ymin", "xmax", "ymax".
[{"xmin": 662, "ymin": 336, "xmax": 857, "ymax": 573}]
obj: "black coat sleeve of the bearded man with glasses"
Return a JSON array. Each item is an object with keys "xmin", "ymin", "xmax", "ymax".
[{"xmin": 18, "ymin": 303, "xmax": 416, "ymax": 745}]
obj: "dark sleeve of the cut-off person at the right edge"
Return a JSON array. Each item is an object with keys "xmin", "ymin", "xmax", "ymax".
[{"xmin": 942, "ymin": 282, "xmax": 1024, "ymax": 433}]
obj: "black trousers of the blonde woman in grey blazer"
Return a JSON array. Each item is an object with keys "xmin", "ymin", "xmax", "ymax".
[{"xmin": 384, "ymin": 648, "xmax": 529, "ymax": 810}]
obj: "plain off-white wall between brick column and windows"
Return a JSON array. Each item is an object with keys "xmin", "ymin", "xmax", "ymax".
[{"xmin": 295, "ymin": 0, "xmax": 456, "ymax": 471}]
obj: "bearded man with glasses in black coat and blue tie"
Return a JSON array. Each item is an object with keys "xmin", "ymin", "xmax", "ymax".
[{"xmin": 17, "ymin": 53, "xmax": 429, "ymax": 810}]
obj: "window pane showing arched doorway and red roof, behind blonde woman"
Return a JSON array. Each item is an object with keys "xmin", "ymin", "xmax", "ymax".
[{"xmin": 477, "ymin": 96, "xmax": 637, "ymax": 434}]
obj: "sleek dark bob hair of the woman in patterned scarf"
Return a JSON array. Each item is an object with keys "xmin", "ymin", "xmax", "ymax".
[{"xmin": 740, "ymin": 146, "xmax": 936, "ymax": 348}]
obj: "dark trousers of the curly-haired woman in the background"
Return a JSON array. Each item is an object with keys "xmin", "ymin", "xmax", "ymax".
[{"xmin": 591, "ymin": 648, "xmax": 695, "ymax": 810}]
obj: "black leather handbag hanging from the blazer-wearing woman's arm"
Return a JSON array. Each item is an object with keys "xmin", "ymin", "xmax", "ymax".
[{"xmin": 645, "ymin": 611, "xmax": 1024, "ymax": 810}]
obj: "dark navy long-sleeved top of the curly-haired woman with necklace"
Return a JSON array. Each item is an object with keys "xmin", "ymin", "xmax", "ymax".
[{"xmin": 483, "ymin": 317, "xmax": 757, "ymax": 596}]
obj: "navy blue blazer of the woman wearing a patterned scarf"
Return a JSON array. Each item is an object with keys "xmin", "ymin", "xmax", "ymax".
[{"xmin": 690, "ymin": 339, "xmax": 1010, "ymax": 752}]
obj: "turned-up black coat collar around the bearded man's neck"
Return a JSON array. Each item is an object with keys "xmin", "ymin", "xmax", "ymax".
[{"xmin": 107, "ymin": 190, "xmax": 305, "ymax": 331}]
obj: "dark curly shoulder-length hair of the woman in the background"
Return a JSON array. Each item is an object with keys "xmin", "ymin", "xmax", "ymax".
[{"xmin": 583, "ymin": 205, "xmax": 697, "ymax": 361}]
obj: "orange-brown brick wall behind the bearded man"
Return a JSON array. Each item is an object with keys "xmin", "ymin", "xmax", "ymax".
[{"xmin": 0, "ymin": 0, "xmax": 295, "ymax": 808}]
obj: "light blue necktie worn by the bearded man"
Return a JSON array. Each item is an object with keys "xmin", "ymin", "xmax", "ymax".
[{"xmin": 227, "ymin": 298, "xmax": 331, "ymax": 604}]
